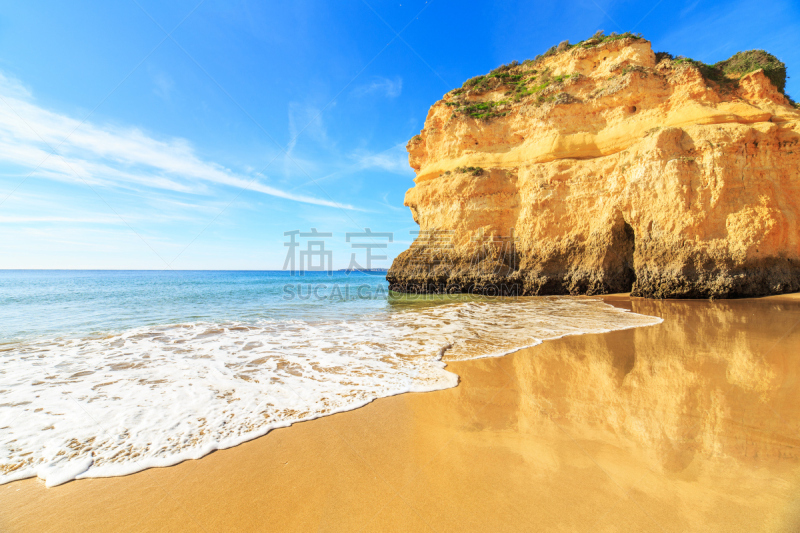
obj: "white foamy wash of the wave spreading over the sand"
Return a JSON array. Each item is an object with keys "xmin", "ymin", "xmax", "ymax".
[{"xmin": 0, "ymin": 298, "xmax": 660, "ymax": 486}]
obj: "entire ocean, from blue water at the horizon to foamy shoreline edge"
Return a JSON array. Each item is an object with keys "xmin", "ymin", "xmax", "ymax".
[{"xmin": 0, "ymin": 270, "xmax": 660, "ymax": 486}]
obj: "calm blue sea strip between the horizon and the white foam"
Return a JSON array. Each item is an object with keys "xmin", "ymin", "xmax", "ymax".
[{"xmin": 0, "ymin": 270, "xmax": 400, "ymax": 343}]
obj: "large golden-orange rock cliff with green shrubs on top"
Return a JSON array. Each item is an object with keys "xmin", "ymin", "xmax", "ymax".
[{"xmin": 387, "ymin": 38, "xmax": 800, "ymax": 298}]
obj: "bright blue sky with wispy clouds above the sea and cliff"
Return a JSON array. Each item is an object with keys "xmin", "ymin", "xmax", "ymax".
[{"xmin": 0, "ymin": 0, "xmax": 800, "ymax": 270}]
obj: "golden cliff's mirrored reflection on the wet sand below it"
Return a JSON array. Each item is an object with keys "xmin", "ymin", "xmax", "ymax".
[{"xmin": 506, "ymin": 300, "xmax": 800, "ymax": 472}]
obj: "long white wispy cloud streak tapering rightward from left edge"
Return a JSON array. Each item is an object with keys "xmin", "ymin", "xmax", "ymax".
[{"xmin": 0, "ymin": 74, "xmax": 357, "ymax": 210}]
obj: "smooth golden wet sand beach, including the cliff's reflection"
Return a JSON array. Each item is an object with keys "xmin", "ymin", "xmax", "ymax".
[{"xmin": 0, "ymin": 295, "xmax": 800, "ymax": 532}]
